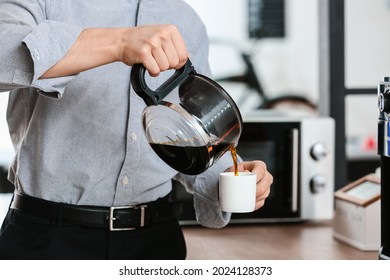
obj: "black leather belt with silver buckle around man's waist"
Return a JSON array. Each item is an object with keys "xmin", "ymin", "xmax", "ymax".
[{"xmin": 11, "ymin": 193, "xmax": 176, "ymax": 231}]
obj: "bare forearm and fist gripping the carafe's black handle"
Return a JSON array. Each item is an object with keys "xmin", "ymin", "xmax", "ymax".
[{"xmin": 40, "ymin": 25, "xmax": 188, "ymax": 79}]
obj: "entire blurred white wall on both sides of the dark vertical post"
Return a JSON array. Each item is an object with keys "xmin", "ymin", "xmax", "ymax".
[{"xmin": 187, "ymin": 0, "xmax": 390, "ymax": 159}]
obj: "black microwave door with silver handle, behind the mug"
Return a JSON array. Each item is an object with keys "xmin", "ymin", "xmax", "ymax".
[{"xmin": 234, "ymin": 123, "xmax": 300, "ymax": 220}]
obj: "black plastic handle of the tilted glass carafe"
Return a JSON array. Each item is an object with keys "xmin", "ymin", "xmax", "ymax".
[{"xmin": 131, "ymin": 59, "xmax": 196, "ymax": 106}]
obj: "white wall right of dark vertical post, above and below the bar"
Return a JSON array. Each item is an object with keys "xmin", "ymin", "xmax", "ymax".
[{"xmin": 345, "ymin": 0, "xmax": 390, "ymax": 158}]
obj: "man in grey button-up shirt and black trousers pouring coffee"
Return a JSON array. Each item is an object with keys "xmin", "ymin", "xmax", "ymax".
[{"xmin": 0, "ymin": 0, "xmax": 272, "ymax": 259}]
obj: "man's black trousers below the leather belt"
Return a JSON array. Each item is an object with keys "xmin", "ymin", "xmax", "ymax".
[{"xmin": 0, "ymin": 209, "xmax": 186, "ymax": 260}]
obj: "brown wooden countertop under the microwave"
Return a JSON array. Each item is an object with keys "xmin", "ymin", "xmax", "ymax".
[{"xmin": 183, "ymin": 221, "xmax": 378, "ymax": 260}]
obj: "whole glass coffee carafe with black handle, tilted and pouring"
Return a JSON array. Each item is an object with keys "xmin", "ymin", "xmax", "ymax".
[{"xmin": 131, "ymin": 60, "xmax": 242, "ymax": 175}]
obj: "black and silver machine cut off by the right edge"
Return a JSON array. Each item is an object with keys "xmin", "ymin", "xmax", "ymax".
[{"xmin": 378, "ymin": 77, "xmax": 390, "ymax": 260}]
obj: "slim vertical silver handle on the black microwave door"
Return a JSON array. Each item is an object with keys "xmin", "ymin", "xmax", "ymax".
[{"xmin": 291, "ymin": 128, "xmax": 299, "ymax": 212}]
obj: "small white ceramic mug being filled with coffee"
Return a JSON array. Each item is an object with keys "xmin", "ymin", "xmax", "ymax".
[{"xmin": 219, "ymin": 172, "xmax": 257, "ymax": 213}]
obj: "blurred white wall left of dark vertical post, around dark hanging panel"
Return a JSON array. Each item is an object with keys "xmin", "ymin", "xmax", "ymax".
[{"xmin": 186, "ymin": 0, "xmax": 319, "ymax": 108}]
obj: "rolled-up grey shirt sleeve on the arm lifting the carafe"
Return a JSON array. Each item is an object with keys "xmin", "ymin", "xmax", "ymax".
[{"xmin": 0, "ymin": 0, "xmax": 82, "ymax": 98}]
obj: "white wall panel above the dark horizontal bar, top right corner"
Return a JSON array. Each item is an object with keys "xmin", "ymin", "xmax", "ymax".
[{"xmin": 345, "ymin": 0, "xmax": 390, "ymax": 88}]
